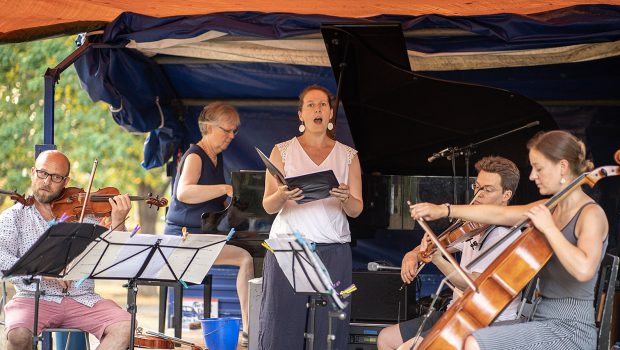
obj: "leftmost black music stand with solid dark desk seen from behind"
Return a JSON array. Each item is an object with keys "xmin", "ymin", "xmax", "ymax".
[{"xmin": 2, "ymin": 223, "xmax": 107, "ymax": 350}]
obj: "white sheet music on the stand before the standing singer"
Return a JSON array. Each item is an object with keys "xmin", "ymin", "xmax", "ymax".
[{"xmin": 266, "ymin": 235, "xmax": 327, "ymax": 293}]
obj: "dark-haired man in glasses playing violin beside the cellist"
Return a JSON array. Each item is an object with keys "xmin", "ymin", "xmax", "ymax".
[{"xmin": 377, "ymin": 157, "xmax": 520, "ymax": 350}]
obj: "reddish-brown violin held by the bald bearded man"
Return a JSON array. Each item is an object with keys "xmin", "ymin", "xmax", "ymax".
[{"xmin": 51, "ymin": 187, "xmax": 168, "ymax": 222}]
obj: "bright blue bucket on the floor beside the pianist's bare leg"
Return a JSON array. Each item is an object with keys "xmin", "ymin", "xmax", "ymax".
[{"xmin": 200, "ymin": 317, "xmax": 241, "ymax": 350}]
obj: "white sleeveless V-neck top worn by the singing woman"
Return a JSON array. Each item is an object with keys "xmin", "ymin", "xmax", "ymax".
[{"xmin": 269, "ymin": 137, "xmax": 357, "ymax": 243}]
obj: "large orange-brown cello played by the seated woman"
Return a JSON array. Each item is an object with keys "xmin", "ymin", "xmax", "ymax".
[{"xmin": 419, "ymin": 166, "xmax": 620, "ymax": 349}]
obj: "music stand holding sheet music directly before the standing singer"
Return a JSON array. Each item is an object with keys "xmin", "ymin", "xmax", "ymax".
[{"xmin": 267, "ymin": 232, "xmax": 353, "ymax": 350}]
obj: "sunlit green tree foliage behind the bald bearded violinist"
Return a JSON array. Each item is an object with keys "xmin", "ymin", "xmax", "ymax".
[{"xmin": 0, "ymin": 37, "xmax": 169, "ymax": 232}]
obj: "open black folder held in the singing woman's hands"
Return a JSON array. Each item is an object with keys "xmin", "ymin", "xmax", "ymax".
[{"xmin": 254, "ymin": 147, "xmax": 340, "ymax": 204}]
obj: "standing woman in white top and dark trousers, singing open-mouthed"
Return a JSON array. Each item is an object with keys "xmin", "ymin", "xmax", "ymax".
[{"xmin": 259, "ymin": 85, "xmax": 363, "ymax": 350}]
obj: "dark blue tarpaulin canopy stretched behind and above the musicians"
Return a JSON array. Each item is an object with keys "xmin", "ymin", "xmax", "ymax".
[{"xmin": 65, "ymin": 5, "xmax": 620, "ymax": 262}]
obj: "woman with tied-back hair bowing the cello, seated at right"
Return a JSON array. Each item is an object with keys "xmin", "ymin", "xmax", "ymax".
[{"xmin": 411, "ymin": 131, "xmax": 608, "ymax": 350}]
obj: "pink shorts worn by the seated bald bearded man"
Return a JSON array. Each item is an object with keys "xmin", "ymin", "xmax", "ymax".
[{"xmin": 4, "ymin": 298, "xmax": 131, "ymax": 339}]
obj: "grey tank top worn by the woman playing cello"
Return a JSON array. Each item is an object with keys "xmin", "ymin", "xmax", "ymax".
[{"xmin": 538, "ymin": 202, "xmax": 607, "ymax": 300}]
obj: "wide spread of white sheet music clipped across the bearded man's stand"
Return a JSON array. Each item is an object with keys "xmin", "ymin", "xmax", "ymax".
[{"xmin": 64, "ymin": 231, "xmax": 226, "ymax": 283}]
